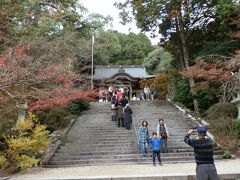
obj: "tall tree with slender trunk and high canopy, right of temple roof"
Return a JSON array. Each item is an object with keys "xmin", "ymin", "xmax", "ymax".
[{"xmin": 116, "ymin": 0, "xmax": 217, "ymax": 111}]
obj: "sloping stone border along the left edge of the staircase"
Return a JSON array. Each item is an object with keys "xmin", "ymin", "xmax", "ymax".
[{"xmin": 42, "ymin": 119, "xmax": 77, "ymax": 166}]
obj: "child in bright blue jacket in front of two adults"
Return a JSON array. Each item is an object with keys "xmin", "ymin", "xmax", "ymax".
[{"xmin": 149, "ymin": 132, "xmax": 162, "ymax": 166}]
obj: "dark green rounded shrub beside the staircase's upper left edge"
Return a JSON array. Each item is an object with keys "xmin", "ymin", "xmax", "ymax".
[{"xmin": 66, "ymin": 99, "xmax": 89, "ymax": 115}]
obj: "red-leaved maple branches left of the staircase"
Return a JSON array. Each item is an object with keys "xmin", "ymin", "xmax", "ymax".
[{"xmin": 0, "ymin": 45, "xmax": 97, "ymax": 111}]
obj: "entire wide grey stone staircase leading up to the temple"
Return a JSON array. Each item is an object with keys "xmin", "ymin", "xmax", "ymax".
[{"xmin": 46, "ymin": 101, "xmax": 223, "ymax": 167}]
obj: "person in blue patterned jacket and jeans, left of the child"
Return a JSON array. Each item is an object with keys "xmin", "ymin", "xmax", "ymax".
[{"xmin": 138, "ymin": 120, "xmax": 149, "ymax": 157}]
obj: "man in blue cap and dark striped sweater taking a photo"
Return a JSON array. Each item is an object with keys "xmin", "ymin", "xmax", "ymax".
[{"xmin": 184, "ymin": 127, "xmax": 219, "ymax": 180}]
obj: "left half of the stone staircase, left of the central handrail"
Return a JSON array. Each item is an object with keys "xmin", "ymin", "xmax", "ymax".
[{"xmin": 47, "ymin": 103, "xmax": 139, "ymax": 167}]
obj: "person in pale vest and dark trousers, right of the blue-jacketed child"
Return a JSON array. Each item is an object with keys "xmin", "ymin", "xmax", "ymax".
[{"xmin": 157, "ymin": 118, "xmax": 169, "ymax": 153}]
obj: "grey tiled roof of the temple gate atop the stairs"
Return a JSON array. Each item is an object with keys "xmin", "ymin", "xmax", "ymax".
[{"xmin": 94, "ymin": 65, "xmax": 155, "ymax": 79}]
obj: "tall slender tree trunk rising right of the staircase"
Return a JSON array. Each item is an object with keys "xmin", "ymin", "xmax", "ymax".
[{"xmin": 178, "ymin": 15, "xmax": 199, "ymax": 113}]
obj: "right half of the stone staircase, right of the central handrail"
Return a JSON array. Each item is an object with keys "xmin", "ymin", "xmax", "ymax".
[{"xmin": 132, "ymin": 101, "xmax": 222, "ymax": 164}]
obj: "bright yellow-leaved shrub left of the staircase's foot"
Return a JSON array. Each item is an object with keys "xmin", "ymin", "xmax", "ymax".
[{"xmin": 6, "ymin": 114, "xmax": 49, "ymax": 170}]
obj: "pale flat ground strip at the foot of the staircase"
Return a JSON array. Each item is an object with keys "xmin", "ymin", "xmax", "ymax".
[{"xmin": 10, "ymin": 159, "xmax": 240, "ymax": 180}]
